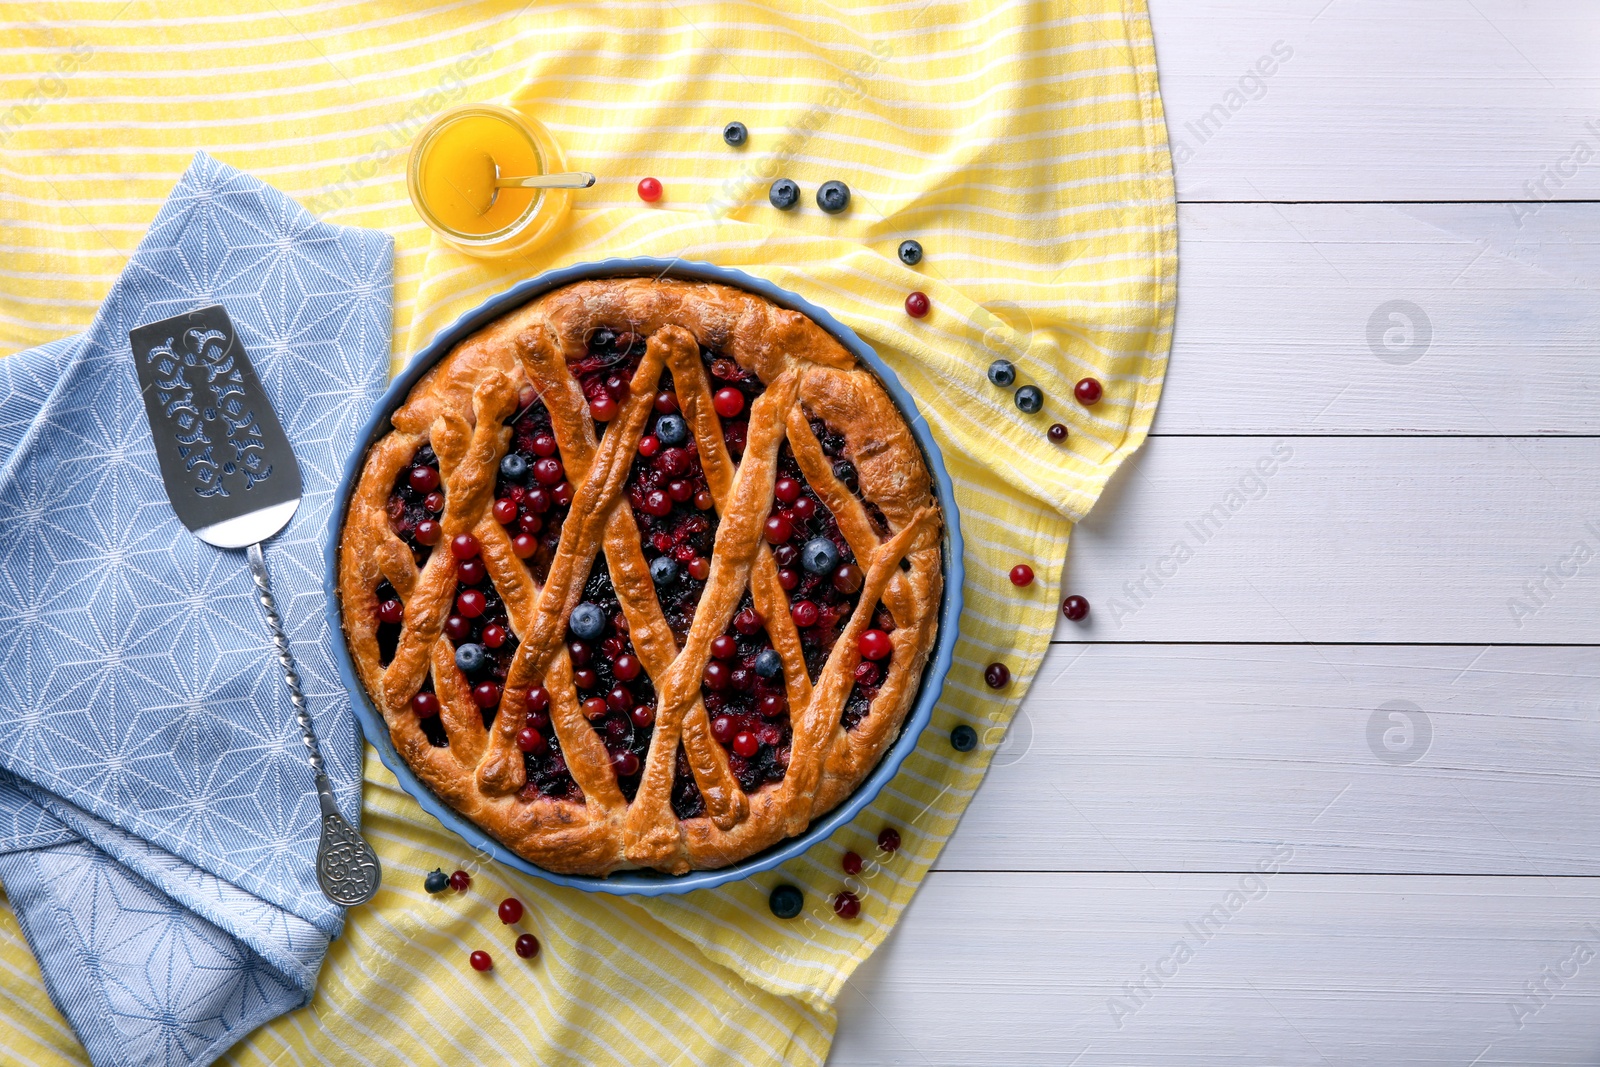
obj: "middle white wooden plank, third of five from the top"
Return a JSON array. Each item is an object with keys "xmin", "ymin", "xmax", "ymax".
[{"xmin": 1037, "ymin": 437, "xmax": 1600, "ymax": 645}]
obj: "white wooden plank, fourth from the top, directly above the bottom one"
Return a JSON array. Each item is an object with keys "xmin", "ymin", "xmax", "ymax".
[{"xmin": 938, "ymin": 645, "xmax": 1600, "ymax": 875}]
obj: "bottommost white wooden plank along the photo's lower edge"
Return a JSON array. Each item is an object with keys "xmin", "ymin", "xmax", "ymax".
[{"xmin": 829, "ymin": 876, "xmax": 1600, "ymax": 1067}]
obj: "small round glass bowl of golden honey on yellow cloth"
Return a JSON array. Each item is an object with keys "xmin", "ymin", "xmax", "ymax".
[{"xmin": 406, "ymin": 104, "xmax": 573, "ymax": 258}]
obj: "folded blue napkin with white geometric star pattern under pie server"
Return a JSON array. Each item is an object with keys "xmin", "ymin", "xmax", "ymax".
[{"xmin": 0, "ymin": 154, "xmax": 394, "ymax": 1067}]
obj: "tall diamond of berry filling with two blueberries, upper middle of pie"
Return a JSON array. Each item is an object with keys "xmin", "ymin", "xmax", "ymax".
[{"xmin": 624, "ymin": 374, "xmax": 717, "ymax": 645}]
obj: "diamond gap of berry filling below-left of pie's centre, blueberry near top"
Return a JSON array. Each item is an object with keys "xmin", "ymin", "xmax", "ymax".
[{"xmin": 566, "ymin": 555, "xmax": 656, "ymax": 801}]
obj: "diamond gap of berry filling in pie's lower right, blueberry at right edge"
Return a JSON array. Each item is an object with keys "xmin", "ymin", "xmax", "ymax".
[{"xmin": 701, "ymin": 593, "xmax": 792, "ymax": 793}]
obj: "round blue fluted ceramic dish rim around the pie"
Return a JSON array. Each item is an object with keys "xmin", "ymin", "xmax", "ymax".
[{"xmin": 323, "ymin": 259, "xmax": 962, "ymax": 896}]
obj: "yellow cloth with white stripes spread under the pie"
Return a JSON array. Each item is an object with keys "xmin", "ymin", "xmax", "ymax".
[{"xmin": 0, "ymin": 0, "xmax": 1176, "ymax": 1067}]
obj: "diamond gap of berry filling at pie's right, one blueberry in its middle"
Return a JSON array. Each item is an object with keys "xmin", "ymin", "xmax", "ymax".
[{"xmin": 766, "ymin": 442, "xmax": 862, "ymax": 681}]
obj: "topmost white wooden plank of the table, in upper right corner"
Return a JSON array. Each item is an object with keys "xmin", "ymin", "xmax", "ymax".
[{"xmin": 1149, "ymin": 0, "xmax": 1600, "ymax": 200}]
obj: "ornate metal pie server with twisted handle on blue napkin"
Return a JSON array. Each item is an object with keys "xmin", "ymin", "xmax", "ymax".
[{"xmin": 128, "ymin": 306, "xmax": 382, "ymax": 907}]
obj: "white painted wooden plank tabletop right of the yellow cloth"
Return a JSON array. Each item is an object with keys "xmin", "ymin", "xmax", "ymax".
[{"xmin": 832, "ymin": 0, "xmax": 1600, "ymax": 1067}]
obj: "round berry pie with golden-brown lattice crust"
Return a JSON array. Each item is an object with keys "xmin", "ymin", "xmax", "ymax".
[{"xmin": 339, "ymin": 278, "xmax": 942, "ymax": 875}]
